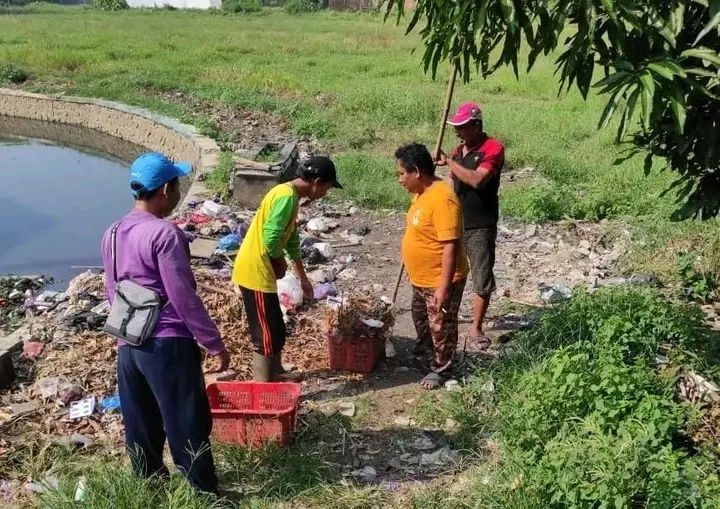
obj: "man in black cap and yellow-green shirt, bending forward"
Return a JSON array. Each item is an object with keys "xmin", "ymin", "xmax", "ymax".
[{"xmin": 232, "ymin": 156, "xmax": 342, "ymax": 382}]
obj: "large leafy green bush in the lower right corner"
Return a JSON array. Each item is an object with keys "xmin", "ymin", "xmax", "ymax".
[{"xmin": 450, "ymin": 287, "xmax": 720, "ymax": 509}]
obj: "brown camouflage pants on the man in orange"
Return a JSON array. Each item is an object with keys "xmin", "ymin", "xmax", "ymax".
[{"xmin": 412, "ymin": 279, "xmax": 465, "ymax": 373}]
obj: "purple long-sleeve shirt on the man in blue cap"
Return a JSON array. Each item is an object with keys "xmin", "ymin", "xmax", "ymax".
[{"xmin": 102, "ymin": 209, "xmax": 225, "ymax": 355}]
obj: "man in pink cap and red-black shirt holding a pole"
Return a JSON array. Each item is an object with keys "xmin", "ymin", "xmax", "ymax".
[{"xmin": 438, "ymin": 102, "xmax": 505, "ymax": 350}]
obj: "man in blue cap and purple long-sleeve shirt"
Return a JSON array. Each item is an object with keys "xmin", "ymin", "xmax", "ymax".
[{"xmin": 102, "ymin": 152, "xmax": 230, "ymax": 492}]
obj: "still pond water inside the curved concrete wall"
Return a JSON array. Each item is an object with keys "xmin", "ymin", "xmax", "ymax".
[{"xmin": 0, "ymin": 137, "xmax": 132, "ymax": 288}]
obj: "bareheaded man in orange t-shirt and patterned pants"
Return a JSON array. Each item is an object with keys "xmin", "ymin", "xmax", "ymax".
[{"xmin": 395, "ymin": 143, "xmax": 468, "ymax": 389}]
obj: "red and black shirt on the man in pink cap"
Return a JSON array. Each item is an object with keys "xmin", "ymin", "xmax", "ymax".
[{"xmin": 450, "ymin": 136, "xmax": 505, "ymax": 230}]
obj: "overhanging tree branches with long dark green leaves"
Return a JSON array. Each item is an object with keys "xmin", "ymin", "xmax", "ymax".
[{"xmin": 386, "ymin": 0, "xmax": 720, "ymax": 219}]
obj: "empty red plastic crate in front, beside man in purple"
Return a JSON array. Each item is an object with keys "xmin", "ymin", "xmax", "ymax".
[{"xmin": 207, "ymin": 382, "xmax": 301, "ymax": 447}]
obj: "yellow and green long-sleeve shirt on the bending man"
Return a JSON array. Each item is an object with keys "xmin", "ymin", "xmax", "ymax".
[{"xmin": 232, "ymin": 184, "xmax": 300, "ymax": 293}]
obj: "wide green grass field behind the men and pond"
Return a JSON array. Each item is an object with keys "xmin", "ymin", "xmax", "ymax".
[{"xmin": 0, "ymin": 6, "xmax": 688, "ymax": 220}]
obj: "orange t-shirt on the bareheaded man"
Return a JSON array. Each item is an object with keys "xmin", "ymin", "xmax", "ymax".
[{"xmin": 402, "ymin": 180, "xmax": 468, "ymax": 288}]
